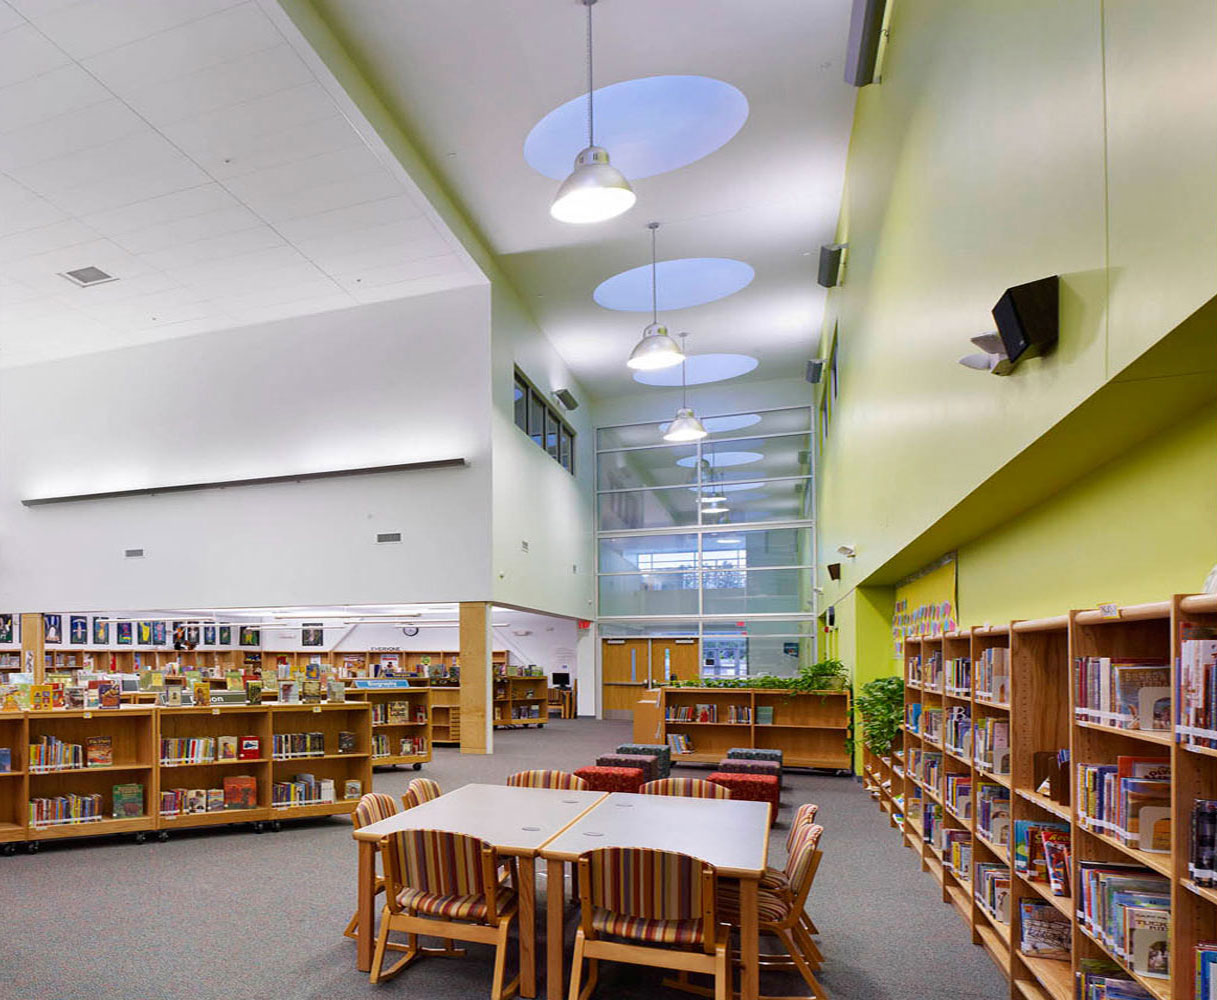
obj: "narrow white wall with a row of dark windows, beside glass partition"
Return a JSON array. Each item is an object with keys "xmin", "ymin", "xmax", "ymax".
[{"xmin": 492, "ymin": 281, "xmax": 595, "ymax": 618}]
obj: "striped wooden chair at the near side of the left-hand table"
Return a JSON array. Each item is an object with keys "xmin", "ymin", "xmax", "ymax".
[{"xmin": 370, "ymin": 830, "xmax": 520, "ymax": 1000}]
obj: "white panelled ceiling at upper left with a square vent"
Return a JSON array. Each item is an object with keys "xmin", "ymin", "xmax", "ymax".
[{"xmin": 0, "ymin": 0, "xmax": 484, "ymax": 366}]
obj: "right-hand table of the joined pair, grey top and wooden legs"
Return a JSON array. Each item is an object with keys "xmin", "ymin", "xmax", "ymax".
[{"xmin": 540, "ymin": 792, "xmax": 769, "ymax": 1000}]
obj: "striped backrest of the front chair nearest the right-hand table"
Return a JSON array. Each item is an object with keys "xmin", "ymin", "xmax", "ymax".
[{"xmin": 579, "ymin": 847, "xmax": 716, "ymax": 929}]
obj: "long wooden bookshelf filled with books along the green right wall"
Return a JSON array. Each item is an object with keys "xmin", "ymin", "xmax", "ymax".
[{"xmin": 864, "ymin": 595, "xmax": 1217, "ymax": 1000}]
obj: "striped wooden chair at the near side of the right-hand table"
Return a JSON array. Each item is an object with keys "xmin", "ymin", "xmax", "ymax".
[{"xmin": 570, "ymin": 847, "xmax": 731, "ymax": 1000}]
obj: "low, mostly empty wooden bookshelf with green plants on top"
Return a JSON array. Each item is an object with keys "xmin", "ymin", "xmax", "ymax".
[{"xmin": 656, "ymin": 687, "xmax": 853, "ymax": 770}]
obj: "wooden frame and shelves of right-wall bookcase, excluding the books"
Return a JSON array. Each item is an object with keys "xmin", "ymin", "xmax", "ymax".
[{"xmin": 864, "ymin": 595, "xmax": 1217, "ymax": 1000}]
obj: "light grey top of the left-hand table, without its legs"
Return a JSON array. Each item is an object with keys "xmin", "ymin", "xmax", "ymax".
[{"xmin": 355, "ymin": 785, "xmax": 606, "ymax": 854}]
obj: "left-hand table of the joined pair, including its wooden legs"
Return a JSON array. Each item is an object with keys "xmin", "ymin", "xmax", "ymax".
[{"xmin": 354, "ymin": 785, "xmax": 607, "ymax": 996}]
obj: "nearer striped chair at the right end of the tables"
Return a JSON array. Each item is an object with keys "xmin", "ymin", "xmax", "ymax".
[{"xmin": 718, "ymin": 824, "xmax": 828, "ymax": 998}]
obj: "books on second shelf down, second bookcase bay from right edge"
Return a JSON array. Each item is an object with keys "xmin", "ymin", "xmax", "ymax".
[{"xmin": 1077, "ymin": 755, "xmax": 1171, "ymax": 854}]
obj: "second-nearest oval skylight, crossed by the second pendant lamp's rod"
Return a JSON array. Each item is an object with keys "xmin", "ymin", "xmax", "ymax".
[{"xmin": 591, "ymin": 257, "xmax": 756, "ymax": 313}]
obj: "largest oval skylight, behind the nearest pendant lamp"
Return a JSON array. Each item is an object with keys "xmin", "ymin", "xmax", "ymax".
[{"xmin": 525, "ymin": 77, "xmax": 748, "ymax": 181}]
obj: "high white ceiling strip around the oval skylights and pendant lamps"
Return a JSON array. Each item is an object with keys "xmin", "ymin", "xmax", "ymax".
[{"xmin": 315, "ymin": 0, "xmax": 856, "ymax": 397}]
